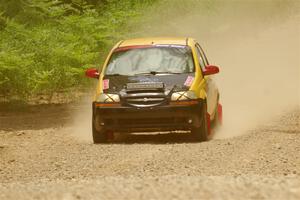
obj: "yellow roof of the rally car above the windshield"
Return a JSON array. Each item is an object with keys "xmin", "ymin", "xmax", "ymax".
[{"xmin": 118, "ymin": 37, "xmax": 189, "ymax": 47}]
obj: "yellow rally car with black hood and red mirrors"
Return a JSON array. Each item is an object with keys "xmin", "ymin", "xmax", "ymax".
[{"xmin": 86, "ymin": 38, "xmax": 222, "ymax": 143}]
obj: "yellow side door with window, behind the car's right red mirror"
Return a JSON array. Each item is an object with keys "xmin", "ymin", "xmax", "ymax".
[{"xmin": 196, "ymin": 43, "xmax": 218, "ymax": 119}]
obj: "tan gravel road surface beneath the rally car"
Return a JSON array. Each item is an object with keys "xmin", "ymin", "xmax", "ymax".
[{"xmin": 0, "ymin": 106, "xmax": 300, "ymax": 199}]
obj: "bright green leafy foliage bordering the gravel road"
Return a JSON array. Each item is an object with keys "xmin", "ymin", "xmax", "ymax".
[{"xmin": 0, "ymin": 0, "xmax": 154, "ymax": 99}]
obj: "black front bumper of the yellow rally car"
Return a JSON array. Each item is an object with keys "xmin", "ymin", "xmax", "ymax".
[{"xmin": 93, "ymin": 99, "xmax": 205, "ymax": 132}]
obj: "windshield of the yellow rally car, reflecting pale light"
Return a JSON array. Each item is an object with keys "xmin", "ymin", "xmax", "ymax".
[{"xmin": 105, "ymin": 46, "xmax": 194, "ymax": 76}]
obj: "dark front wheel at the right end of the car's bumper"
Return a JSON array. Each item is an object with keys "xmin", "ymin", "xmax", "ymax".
[{"xmin": 192, "ymin": 103, "xmax": 210, "ymax": 142}]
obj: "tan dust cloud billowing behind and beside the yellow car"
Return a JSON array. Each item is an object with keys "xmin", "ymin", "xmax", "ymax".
[{"xmin": 71, "ymin": 0, "xmax": 300, "ymax": 140}]
